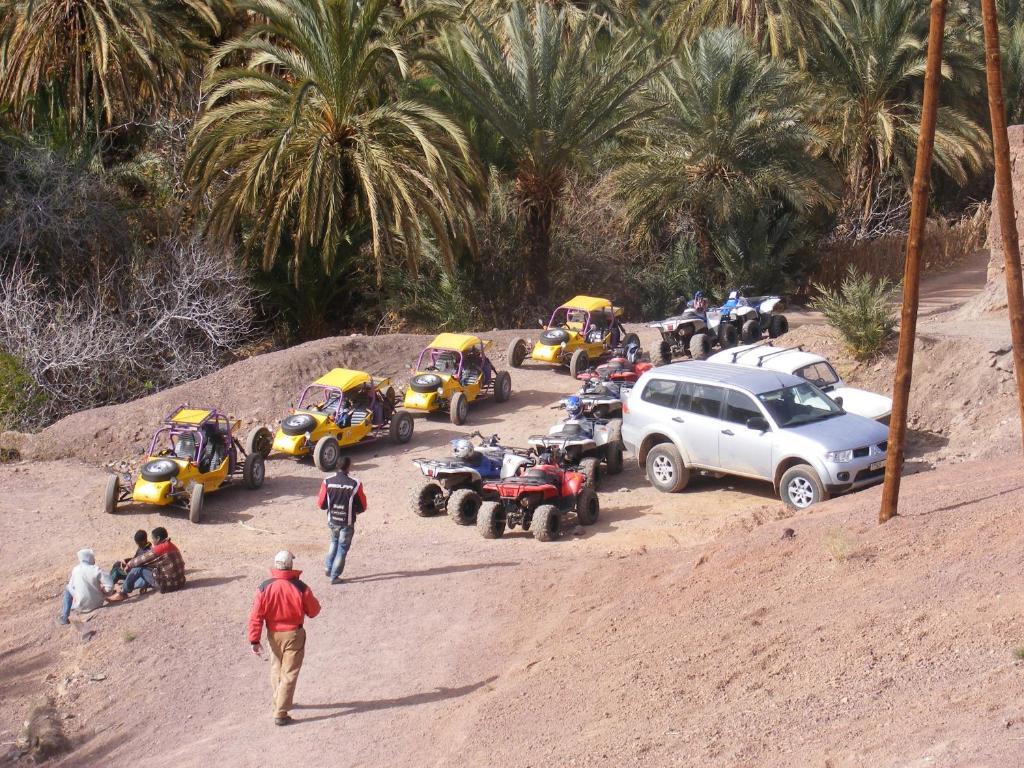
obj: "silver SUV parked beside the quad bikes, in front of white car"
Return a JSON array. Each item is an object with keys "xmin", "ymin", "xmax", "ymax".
[{"xmin": 623, "ymin": 361, "xmax": 889, "ymax": 509}]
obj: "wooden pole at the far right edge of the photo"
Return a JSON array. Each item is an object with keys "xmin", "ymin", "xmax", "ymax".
[{"xmin": 981, "ymin": 0, "xmax": 1024, "ymax": 454}]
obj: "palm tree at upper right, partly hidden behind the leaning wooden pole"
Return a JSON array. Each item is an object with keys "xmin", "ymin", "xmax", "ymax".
[{"xmin": 810, "ymin": 0, "xmax": 988, "ymax": 220}]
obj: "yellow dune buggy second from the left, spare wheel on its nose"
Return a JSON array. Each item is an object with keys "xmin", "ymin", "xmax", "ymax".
[{"xmin": 246, "ymin": 368, "xmax": 413, "ymax": 472}]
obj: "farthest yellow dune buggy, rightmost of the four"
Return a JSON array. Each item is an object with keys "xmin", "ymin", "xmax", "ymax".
[{"xmin": 508, "ymin": 296, "xmax": 640, "ymax": 378}]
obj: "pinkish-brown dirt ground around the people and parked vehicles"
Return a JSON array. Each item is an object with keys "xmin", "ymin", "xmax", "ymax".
[{"xmin": 0, "ymin": 257, "xmax": 1024, "ymax": 768}]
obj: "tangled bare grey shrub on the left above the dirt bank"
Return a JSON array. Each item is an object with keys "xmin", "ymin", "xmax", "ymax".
[{"xmin": 0, "ymin": 242, "xmax": 253, "ymax": 430}]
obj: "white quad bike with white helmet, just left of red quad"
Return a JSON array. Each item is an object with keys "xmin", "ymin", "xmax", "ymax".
[{"xmin": 413, "ymin": 432, "xmax": 534, "ymax": 525}]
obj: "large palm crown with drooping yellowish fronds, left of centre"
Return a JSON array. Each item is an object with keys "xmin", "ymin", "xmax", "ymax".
[{"xmin": 186, "ymin": 0, "xmax": 472, "ymax": 284}]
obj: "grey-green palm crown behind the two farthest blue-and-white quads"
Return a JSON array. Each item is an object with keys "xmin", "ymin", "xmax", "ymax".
[{"xmin": 607, "ymin": 28, "xmax": 833, "ymax": 260}]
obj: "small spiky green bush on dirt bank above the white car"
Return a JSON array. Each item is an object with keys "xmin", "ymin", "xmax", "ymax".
[{"xmin": 811, "ymin": 266, "xmax": 896, "ymax": 360}]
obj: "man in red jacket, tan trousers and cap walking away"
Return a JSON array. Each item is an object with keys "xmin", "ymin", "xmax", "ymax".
[{"xmin": 249, "ymin": 550, "xmax": 319, "ymax": 725}]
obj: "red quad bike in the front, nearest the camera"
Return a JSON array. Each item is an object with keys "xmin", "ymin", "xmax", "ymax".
[{"xmin": 476, "ymin": 455, "xmax": 601, "ymax": 542}]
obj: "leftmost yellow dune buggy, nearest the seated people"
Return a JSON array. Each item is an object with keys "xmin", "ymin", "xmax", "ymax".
[{"xmin": 103, "ymin": 406, "xmax": 265, "ymax": 522}]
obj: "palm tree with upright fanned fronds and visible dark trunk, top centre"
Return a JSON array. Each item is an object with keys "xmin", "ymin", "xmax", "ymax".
[{"xmin": 433, "ymin": 2, "xmax": 654, "ymax": 299}]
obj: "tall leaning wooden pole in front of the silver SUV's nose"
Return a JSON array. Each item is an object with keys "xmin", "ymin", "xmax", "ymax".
[{"xmin": 879, "ymin": 0, "xmax": 946, "ymax": 523}]
